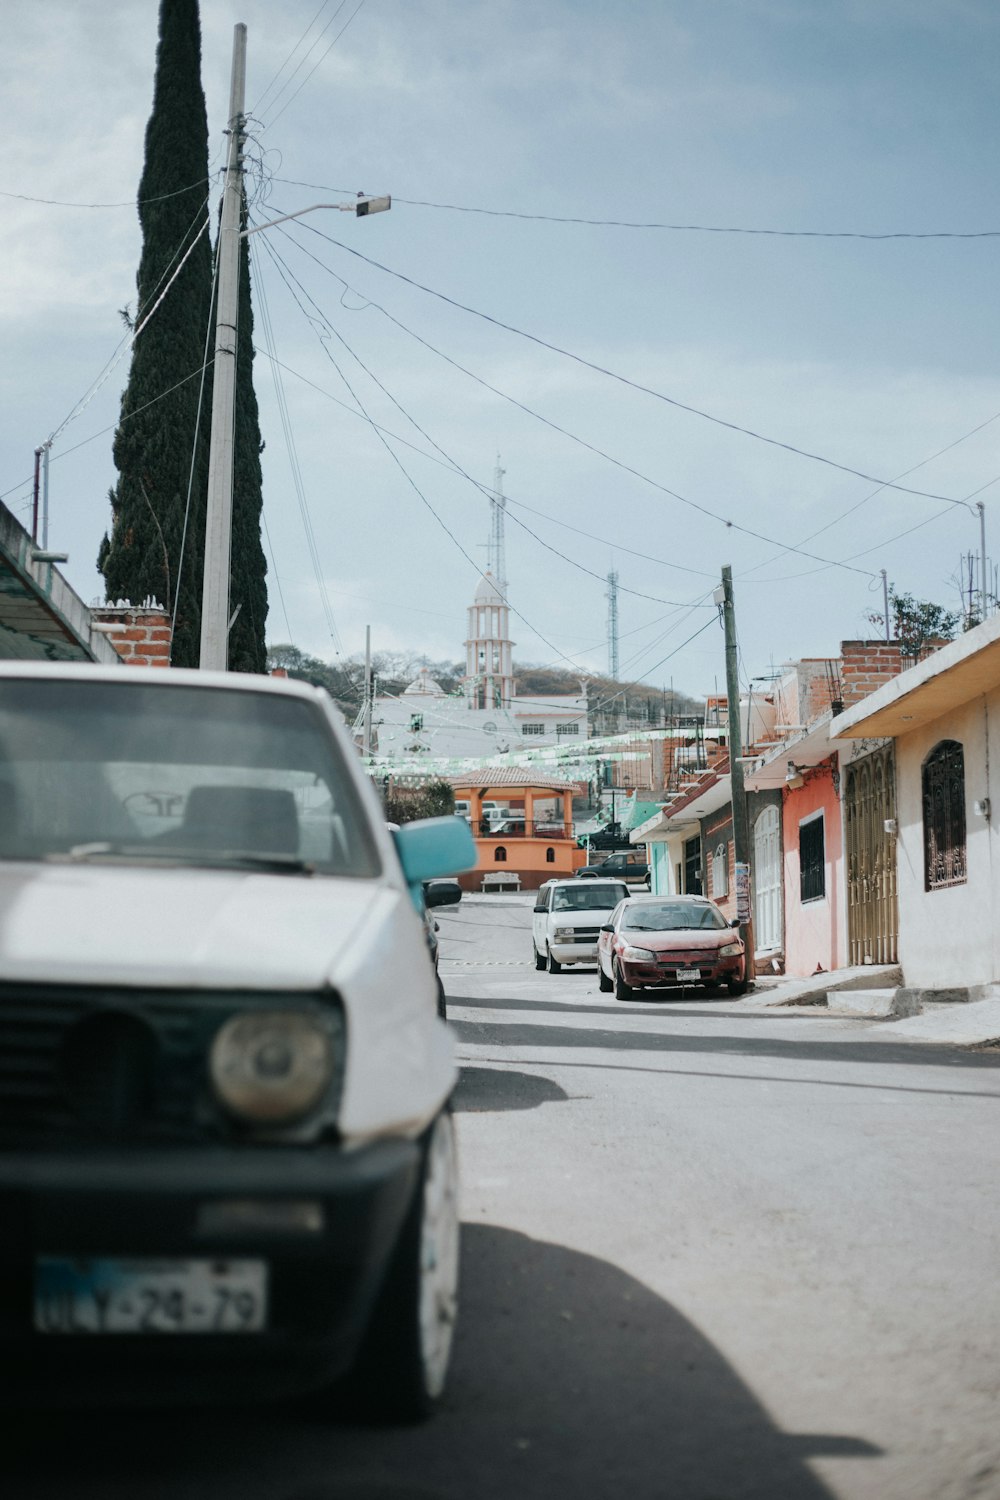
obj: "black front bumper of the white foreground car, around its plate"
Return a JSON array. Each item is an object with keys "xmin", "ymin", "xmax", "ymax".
[{"xmin": 0, "ymin": 1140, "xmax": 421, "ymax": 1404}]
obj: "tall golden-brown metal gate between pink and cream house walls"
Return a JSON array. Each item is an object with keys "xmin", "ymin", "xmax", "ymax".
[{"xmin": 844, "ymin": 746, "xmax": 898, "ymax": 963}]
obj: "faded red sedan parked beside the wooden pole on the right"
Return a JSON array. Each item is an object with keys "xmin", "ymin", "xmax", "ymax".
[{"xmin": 597, "ymin": 896, "xmax": 747, "ymax": 1001}]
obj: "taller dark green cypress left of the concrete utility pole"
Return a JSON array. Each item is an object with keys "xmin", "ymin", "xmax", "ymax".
[{"xmin": 97, "ymin": 0, "xmax": 211, "ymax": 666}]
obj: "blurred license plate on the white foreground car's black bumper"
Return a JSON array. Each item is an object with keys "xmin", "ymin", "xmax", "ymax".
[{"xmin": 34, "ymin": 1256, "xmax": 267, "ymax": 1334}]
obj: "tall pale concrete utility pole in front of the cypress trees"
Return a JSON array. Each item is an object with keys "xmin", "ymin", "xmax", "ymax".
[{"xmin": 199, "ymin": 21, "xmax": 246, "ymax": 672}]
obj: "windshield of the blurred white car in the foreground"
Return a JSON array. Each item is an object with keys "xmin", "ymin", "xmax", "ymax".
[{"xmin": 0, "ymin": 684, "xmax": 379, "ymax": 876}]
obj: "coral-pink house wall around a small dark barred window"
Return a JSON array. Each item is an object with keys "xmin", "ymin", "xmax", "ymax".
[{"xmin": 781, "ymin": 762, "xmax": 847, "ymax": 975}]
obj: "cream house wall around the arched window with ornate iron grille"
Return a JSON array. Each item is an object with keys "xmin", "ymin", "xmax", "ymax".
[{"xmin": 897, "ymin": 690, "xmax": 1000, "ymax": 990}]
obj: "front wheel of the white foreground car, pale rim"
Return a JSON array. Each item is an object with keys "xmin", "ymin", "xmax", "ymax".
[{"xmin": 351, "ymin": 1110, "xmax": 459, "ymax": 1424}]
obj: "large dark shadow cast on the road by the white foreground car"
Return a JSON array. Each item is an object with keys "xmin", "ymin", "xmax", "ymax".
[{"xmin": 0, "ymin": 1224, "xmax": 880, "ymax": 1500}]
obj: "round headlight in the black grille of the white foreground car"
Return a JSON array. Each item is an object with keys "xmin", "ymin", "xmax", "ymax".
[{"xmin": 208, "ymin": 1011, "xmax": 334, "ymax": 1125}]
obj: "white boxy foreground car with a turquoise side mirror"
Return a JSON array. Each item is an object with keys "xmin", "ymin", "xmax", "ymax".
[{"xmin": 0, "ymin": 662, "xmax": 475, "ymax": 1418}]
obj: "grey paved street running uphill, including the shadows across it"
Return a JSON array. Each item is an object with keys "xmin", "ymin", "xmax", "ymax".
[{"xmin": 7, "ymin": 897, "xmax": 1000, "ymax": 1500}]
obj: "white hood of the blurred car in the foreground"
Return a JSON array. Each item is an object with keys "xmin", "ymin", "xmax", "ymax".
[{"xmin": 0, "ymin": 863, "xmax": 395, "ymax": 990}]
